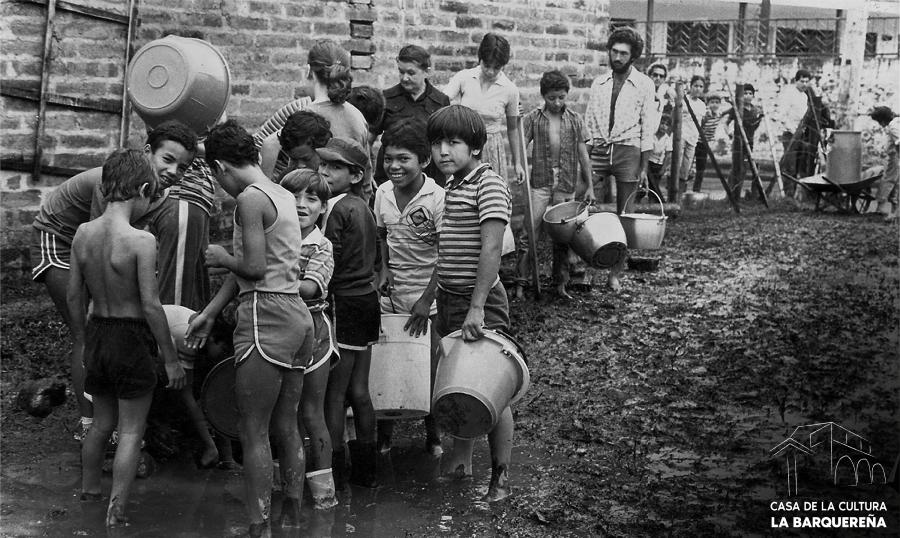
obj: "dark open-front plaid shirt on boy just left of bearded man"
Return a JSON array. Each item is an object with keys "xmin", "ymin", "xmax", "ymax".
[{"xmin": 522, "ymin": 107, "xmax": 588, "ymax": 193}]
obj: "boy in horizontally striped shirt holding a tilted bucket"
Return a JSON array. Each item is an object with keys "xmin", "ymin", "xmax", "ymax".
[{"xmin": 423, "ymin": 105, "xmax": 513, "ymax": 502}]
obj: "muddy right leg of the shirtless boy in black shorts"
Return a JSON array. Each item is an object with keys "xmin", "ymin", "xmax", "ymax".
[{"xmin": 107, "ymin": 392, "xmax": 153, "ymax": 526}]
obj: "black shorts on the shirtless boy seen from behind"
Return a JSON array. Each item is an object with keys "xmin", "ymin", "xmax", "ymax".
[{"xmin": 84, "ymin": 317, "xmax": 159, "ymax": 400}]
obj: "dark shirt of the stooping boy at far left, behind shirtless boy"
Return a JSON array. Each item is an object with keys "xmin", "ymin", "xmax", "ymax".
[{"xmin": 33, "ymin": 168, "xmax": 103, "ymax": 243}]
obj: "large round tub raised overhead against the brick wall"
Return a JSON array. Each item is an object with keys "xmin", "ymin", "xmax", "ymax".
[{"xmin": 127, "ymin": 36, "xmax": 231, "ymax": 135}]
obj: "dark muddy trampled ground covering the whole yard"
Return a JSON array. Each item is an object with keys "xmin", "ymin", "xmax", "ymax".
[{"xmin": 0, "ymin": 199, "xmax": 900, "ymax": 536}]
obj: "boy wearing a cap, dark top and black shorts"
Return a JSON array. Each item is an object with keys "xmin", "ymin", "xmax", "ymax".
[{"xmin": 316, "ymin": 138, "xmax": 381, "ymax": 491}]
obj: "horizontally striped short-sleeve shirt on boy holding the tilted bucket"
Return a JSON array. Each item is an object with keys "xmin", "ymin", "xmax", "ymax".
[{"xmin": 437, "ymin": 163, "xmax": 512, "ymax": 294}]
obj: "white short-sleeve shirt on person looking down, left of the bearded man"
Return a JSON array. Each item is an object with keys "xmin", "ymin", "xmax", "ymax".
[{"xmin": 444, "ymin": 66, "xmax": 519, "ymax": 134}]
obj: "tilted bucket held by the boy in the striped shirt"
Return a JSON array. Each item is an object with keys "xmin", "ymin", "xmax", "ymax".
[{"xmin": 432, "ymin": 330, "xmax": 530, "ymax": 439}]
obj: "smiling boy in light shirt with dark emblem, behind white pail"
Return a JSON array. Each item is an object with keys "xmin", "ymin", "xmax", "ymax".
[{"xmin": 375, "ymin": 120, "xmax": 444, "ymax": 457}]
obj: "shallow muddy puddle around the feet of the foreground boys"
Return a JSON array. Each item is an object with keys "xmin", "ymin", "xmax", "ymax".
[{"xmin": 0, "ymin": 441, "xmax": 561, "ymax": 538}]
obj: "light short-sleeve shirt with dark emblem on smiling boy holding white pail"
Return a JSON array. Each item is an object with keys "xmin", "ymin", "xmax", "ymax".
[{"xmin": 375, "ymin": 176, "xmax": 444, "ymax": 290}]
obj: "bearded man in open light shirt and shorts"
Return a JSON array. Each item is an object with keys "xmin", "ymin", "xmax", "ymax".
[{"xmin": 585, "ymin": 28, "xmax": 659, "ymax": 291}]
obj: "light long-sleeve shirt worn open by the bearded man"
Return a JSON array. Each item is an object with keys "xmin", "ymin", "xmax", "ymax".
[{"xmin": 584, "ymin": 67, "xmax": 659, "ymax": 151}]
